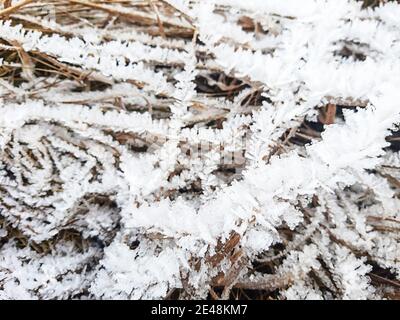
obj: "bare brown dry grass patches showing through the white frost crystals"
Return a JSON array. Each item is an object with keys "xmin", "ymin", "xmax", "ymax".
[{"xmin": 0, "ymin": 0, "xmax": 400, "ymax": 299}]
